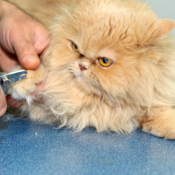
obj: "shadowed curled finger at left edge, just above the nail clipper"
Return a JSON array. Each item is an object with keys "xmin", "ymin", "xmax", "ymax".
[{"xmin": 0, "ymin": 46, "xmax": 18, "ymax": 72}]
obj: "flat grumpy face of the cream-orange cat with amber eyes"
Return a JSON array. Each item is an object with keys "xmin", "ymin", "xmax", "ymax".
[{"xmin": 43, "ymin": 0, "xmax": 175, "ymax": 102}]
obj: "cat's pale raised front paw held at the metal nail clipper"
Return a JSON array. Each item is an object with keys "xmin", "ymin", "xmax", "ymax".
[{"xmin": 7, "ymin": 66, "xmax": 44, "ymax": 104}]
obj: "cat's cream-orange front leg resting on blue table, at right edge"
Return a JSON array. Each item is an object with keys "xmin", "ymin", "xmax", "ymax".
[{"xmin": 141, "ymin": 107, "xmax": 175, "ymax": 139}]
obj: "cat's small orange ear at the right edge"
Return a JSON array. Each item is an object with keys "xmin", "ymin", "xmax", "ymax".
[{"xmin": 159, "ymin": 19, "xmax": 175, "ymax": 38}]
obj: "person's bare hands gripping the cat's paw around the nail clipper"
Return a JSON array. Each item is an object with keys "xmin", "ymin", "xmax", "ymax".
[{"xmin": 0, "ymin": 1, "xmax": 50, "ymax": 116}]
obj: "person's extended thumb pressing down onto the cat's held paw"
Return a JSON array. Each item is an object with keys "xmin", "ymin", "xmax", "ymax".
[{"xmin": 13, "ymin": 35, "xmax": 40, "ymax": 69}]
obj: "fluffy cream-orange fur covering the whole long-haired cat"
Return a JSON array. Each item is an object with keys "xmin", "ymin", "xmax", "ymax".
[{"xmin": 5, "ymin": 0, "xmax": 175, "ymax": 139}]
